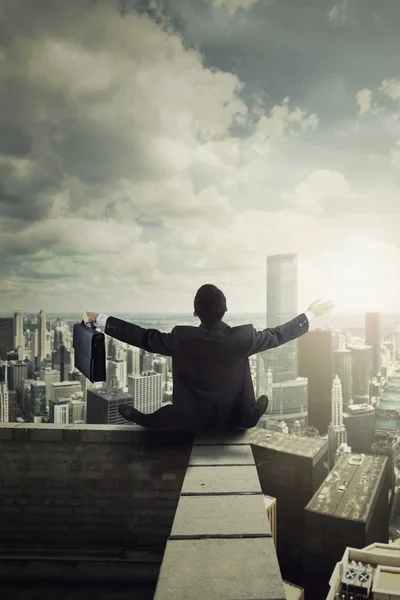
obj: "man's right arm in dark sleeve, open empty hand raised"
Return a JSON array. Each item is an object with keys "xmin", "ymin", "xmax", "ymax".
[{"xmin": 247, "ymin": 300, "xmax": 333, "ymax": 356}]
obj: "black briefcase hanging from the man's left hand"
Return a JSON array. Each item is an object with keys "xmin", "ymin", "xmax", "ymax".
[{"xmin": 72, "ymin": 320, "xmax": 106, "ymax": 383}]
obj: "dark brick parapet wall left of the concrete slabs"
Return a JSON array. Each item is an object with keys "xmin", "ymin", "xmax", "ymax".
[{"xmin": 0, "ymin": 423, "xmax": 193, "ymax": 549}]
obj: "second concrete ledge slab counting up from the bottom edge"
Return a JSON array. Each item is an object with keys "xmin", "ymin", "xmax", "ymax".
[{"xmin": 170, "ymin": 495, "xmax": 271, "ymax": 539}]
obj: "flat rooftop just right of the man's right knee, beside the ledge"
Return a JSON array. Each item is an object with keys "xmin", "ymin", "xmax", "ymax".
[{"xmin": 249, "ymin": 427, "xmax": 327, "ymax": 458}]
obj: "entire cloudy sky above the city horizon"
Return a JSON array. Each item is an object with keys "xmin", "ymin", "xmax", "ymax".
[{"xmin": 0, "ymin": 0, "xmax": 400, "ymax": 313}]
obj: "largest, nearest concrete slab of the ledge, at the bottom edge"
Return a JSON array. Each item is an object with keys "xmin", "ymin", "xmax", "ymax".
[{"xmin": 154, "ymin": 538, "xmax": 286, "ymax": 600}]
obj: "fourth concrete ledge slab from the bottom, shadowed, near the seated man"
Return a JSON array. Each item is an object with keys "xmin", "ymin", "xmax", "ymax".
[{"xmin": 189, "ymin": 444, "xmax": 254, "ymax": 466}]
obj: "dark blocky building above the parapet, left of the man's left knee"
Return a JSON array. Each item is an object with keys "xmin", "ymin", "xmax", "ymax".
[{"xmin": 86, "ymin": 388, "xmax": 133, "ymax": 425}]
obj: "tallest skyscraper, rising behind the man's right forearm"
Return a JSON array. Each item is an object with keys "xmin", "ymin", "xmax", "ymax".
[{"xmin": 263, "ymin": 254, "xmax": 297, "ymax": 383}]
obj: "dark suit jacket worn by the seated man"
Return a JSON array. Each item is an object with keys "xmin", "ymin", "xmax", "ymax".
[{"xmin": 105, "ymin": 313, "xmax": 309, "ymax": 431}]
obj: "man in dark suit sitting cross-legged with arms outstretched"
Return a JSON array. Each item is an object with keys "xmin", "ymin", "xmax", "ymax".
[{"xmin": 83, "ymin": 284, "xmax": 333, "ymax": 433}]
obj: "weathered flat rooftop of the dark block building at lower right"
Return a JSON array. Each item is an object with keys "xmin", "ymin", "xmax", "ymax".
[{"xmin": 306, "ymin": 454, "xmax": 387, "ymax": 521}]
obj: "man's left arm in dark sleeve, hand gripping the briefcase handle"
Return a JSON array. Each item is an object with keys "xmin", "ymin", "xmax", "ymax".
[{"xmin": 83, "ymin": 312, "xmax": 175, "ymax": 356}]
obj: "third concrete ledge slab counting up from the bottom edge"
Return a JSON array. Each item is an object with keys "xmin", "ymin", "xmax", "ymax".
[{"xmin": 181, "ymin": 465, "xmax": 261, "ymax": 495}]
